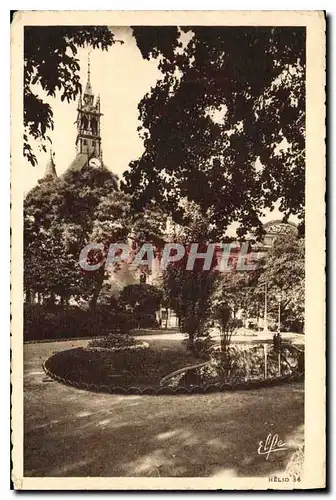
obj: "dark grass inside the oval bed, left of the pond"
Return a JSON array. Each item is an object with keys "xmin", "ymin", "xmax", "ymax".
[{"xmin": 46, "ymin": 347, "xmax": 200, "ymax": 388}]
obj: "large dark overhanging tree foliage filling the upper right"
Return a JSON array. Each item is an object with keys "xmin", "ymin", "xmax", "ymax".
[{"xmin": 123, "ymin": 26, "xmax": 305, "ymax": 238}]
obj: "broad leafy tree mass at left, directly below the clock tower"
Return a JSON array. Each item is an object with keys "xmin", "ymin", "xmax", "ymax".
[{"xmin": 24, "ymin": 166, "xmax": 165, "ymax": 310}]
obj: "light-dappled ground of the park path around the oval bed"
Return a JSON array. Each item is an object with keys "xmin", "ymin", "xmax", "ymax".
[{"xmin": 24, "ymin": 341, "xmax": 304, "ymax": 477}]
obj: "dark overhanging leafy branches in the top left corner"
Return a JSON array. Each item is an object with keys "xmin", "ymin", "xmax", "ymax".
[{"xmin": 23, "ymin": 26, "xmax": 123, "ymax": 166}]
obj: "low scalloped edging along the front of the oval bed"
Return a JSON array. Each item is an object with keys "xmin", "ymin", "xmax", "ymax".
[{"xmin": 42, "ymin": 360, "xmax": 304, "ymax": 396}]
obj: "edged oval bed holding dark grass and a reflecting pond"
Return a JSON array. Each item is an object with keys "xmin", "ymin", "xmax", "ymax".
[{"xmin": 44, "ymin": 345, "xmax": 303, "ymax": 394}]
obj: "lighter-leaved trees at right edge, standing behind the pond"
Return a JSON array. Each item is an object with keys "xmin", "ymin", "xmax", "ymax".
[{"xmin": 213, "ymin": 233, "xmax": 305, "ymax": 332}]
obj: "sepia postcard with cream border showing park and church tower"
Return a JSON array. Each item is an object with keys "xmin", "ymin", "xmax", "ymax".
[{"xmin": 11, "ymin": 11, "xmax": 325, "ymax": 490}]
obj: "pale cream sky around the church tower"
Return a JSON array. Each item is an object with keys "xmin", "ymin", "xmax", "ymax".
[{"xmin": 23, "ymin": 27, "xmax": 161, "ymax": 192}]
